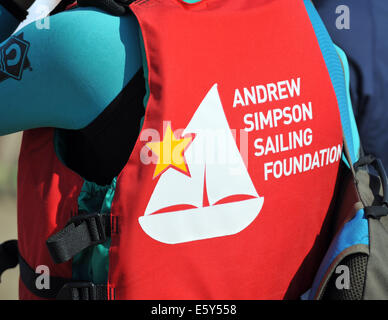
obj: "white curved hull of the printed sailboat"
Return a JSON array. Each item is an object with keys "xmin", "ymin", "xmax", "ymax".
[{"xmin": 139, "ymin": 197, "xmax": 264, "ymax": 244}]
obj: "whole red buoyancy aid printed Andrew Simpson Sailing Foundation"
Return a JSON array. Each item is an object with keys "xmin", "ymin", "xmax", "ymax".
[{"xmin": 15, "ymin": 0, "xmax": 342, "ymax": 299}]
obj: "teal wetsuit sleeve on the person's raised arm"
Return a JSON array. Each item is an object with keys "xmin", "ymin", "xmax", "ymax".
[{"xmin": 0, "ymin": 8, "xmax": 142, "ymax": 135}]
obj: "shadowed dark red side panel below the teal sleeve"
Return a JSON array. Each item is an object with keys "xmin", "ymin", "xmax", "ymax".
[{"xmin": 18, "ymin": 129, "xmax": 83, "ymax": 299}]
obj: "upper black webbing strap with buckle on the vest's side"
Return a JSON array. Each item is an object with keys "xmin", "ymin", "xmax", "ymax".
[{"xmin": 46, "ymin": 213, "xmax": 110, "ymax": 263}]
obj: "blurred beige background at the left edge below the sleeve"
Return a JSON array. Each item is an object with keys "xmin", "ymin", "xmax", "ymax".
[{"xmin": 0, "ymin": 133, "xmax": 22, "ymax": 300}]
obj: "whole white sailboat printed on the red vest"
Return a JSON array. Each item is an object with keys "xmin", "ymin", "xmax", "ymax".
[{"xmin": 139, "ymin": 84, "xmax": 264, "ymax": 244}]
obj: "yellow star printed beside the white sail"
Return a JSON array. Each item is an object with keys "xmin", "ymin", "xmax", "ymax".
[{"xmin": 146, "ymin": 125, "xmax": 193, "ymax": 178}]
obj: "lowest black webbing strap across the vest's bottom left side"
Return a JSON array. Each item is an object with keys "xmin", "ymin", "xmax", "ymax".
[{"xmin": 19, "ymin": 252, "xmax": 108, "ymax": 300}]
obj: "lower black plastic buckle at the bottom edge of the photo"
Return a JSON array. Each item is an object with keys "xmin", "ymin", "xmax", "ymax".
[{"xmin": 57, "ymin": 281, "xmax": 97, "ymax": 300}]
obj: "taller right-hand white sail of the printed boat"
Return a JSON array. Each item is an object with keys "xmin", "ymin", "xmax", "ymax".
[{"xmin": 184, "ymin": 85, "xmax": 258, "ymax": 205}]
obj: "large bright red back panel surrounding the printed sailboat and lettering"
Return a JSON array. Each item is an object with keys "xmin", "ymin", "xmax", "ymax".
[{"xmin": 109, "ymin": 0, "xmax": 342, "ymax": 299}]
